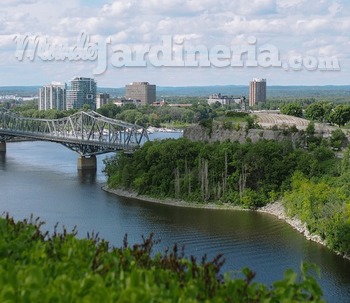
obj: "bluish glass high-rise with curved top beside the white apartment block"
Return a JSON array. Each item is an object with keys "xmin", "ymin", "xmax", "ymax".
[{"xmin": 67, "ymin": 77, "xmax": 97, "ymax": 109}]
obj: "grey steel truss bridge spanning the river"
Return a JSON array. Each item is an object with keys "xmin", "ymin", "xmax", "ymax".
[{"xmin": 0, "ymin": 109, "xmax": 149, "ymax": 169}]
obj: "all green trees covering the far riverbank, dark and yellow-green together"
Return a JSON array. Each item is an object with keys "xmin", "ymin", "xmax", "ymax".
[{"xmin": 105, "ymin": 136, "xmax": 350, "ymax": 254}]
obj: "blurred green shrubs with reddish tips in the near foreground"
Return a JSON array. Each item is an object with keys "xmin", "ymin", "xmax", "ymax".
[{"xmin": 0, "ymin": 217, "xmax": 323, "ymax": 303}]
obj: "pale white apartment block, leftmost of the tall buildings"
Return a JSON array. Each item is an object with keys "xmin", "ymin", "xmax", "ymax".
[{"xmin": 39, "ymin": 82, "xmax": 66, "ymax": 110}]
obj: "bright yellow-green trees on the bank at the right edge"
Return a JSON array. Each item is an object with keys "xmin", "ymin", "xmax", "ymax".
[{"xmin": 283, "ymin": 147, "xmax": 350, "ymax": 256}]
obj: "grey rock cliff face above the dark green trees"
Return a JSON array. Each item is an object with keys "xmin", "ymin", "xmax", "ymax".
[{"xmin": 183, "ymin": 124, "xmax": 304, "ymax": 143}]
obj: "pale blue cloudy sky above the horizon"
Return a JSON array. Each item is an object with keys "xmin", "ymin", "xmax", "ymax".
[{"xmin": 0, "ymin": 0, "xmax": 350, "ymax": 87}]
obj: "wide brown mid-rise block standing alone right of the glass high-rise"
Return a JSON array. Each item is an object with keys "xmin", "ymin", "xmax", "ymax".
[{"xmin": 125, "ymin": 82, "xmax": 156, "ymax": 105}]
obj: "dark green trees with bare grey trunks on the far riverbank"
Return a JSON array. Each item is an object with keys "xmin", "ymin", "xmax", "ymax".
[{"xmin": 106, "ymin": 138, "xmax": 337, "ymax": 208}]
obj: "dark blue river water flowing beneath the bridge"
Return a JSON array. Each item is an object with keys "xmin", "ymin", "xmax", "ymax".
[{"xmin": 0, "ymin": 135, "xmax": 350, "ymax": 302}]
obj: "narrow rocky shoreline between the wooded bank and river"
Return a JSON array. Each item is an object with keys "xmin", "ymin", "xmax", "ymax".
[{"xmin": 102, "ymin": 185, "xmax": 350, "ymax": 260}]
